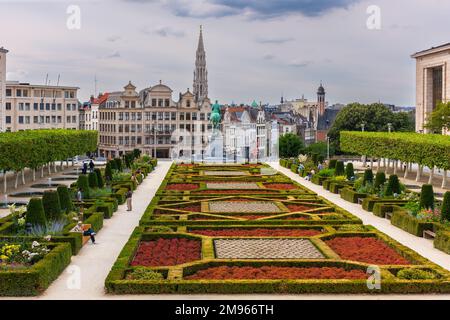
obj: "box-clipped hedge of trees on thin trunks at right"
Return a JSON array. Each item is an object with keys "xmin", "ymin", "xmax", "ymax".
[{"xmin": 341, "ymin": 132, "xmax": 450, "ymax": 170}]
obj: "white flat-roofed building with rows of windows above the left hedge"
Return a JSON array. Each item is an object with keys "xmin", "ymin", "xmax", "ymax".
[{"xmin": 4, "ymin": 81, "xmax": 79, "ymax": 131}]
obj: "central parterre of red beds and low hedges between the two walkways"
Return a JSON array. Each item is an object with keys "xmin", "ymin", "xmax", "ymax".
[{"xmin": 105, "ymin": 164, "xmax": 450, "ymax": 294}]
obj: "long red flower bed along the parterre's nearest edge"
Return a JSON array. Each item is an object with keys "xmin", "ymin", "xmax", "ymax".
[{"xmin": 184, "ymin": 266, "xmax": 367, "ymax": 280}]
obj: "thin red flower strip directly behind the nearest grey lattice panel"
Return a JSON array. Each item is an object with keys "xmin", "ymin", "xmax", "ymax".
[{"xmin": 190, "ymin": 228, "xmax": 321, "ymax": 237}]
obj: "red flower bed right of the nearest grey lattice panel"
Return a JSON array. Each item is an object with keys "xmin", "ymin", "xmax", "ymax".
[{"xmin": 326, "ymin": 237, "xmax": 410, "ymax": 265}]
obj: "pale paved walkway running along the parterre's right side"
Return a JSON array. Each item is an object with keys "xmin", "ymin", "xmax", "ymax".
[{"xmin": 270, "ymin": 163, "xmax": 450, "ymax": 270}]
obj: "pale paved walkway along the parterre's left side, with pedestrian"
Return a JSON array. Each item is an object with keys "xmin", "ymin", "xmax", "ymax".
[{"xmin": 35, "ymin": 162, "xmax": 171, "ymax": 300}]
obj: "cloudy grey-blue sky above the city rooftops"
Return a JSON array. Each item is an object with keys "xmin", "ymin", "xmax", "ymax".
[{"xmin": 0, "ymin": 0, "xmax": 450, "ymax": 105}]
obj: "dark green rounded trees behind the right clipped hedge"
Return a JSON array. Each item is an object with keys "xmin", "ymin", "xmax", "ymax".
[{"xmin": 328, "ymin": 103, "xmax": 414, "ymax": 153}]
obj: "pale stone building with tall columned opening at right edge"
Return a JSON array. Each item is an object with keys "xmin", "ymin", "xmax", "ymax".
[{"xmin": 411, "ymin": 43, "xmax": 450, "ymax": 132}]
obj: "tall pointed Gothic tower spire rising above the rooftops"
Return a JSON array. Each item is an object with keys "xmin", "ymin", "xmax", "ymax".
[{"xmin": 193, "ymin": 25, "xmax": 208, "ymax": 102}]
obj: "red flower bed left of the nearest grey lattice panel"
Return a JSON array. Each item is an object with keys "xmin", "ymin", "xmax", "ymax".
[{"xmin": 131, "ymin": 238, "xmax": 201, "ymax": 267}]
